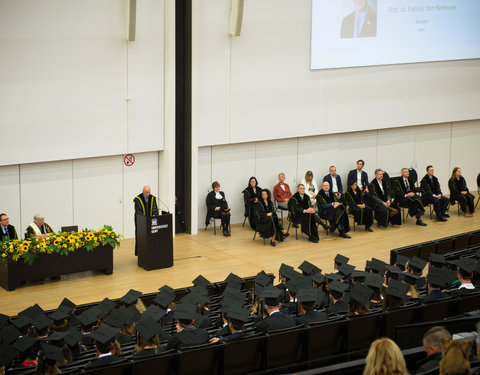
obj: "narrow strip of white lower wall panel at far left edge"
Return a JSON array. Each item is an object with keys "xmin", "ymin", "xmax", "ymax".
[{"xmin": 0, "ymin": 165, "xmax": 21, "ymax": 237}]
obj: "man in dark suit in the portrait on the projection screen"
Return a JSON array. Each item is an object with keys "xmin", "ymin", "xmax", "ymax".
[{"xmin": 340, "ymin": 0, "xmax": 377, "ymax": 38}]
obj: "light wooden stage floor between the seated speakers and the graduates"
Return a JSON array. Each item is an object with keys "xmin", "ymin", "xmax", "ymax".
[{"xmin": 0, "ymin": 212, "xmax": 480, "ymax": 315}]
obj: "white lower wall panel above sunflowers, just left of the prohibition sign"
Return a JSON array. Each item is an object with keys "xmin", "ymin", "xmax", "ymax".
[{"xmin": 73, "ymin": 155, "xmax": 123, "ymax": 232}]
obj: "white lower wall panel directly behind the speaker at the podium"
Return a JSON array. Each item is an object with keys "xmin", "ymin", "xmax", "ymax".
[{"xmin": 122, "ymin": 152, "xmax": 160, "ymax": 238}]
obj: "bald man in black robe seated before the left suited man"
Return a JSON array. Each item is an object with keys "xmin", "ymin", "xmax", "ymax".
[{"xmin": 317, "ymin": 181, "xmax": 351, "ymax": 238}]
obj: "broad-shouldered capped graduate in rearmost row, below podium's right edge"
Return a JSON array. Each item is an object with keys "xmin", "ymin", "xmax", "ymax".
[{"xmin": 167, "ymin": 304, "xmax": 208, "ymax": 350}]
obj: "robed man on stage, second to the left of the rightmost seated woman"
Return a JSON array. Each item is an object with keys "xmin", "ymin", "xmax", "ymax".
[{"xmin": 394, "ymin": 168, "xmax": 427, "ymax": 226}]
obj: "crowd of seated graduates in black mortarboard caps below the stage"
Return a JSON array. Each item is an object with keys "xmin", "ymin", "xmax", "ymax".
[{"xmin": 0, "ymin": 254, "xmax": 480, "ymax": 374}]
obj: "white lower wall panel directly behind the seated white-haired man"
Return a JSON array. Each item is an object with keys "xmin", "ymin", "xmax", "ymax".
[{"xmin": 17, "ymin": 160, "xmax": 74, "ymax": 235}]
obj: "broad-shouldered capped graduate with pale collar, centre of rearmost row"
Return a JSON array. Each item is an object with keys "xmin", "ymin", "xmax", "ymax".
[{"xmin": 255, "ymin": 286, "xmax": 297, "ymax": 333}]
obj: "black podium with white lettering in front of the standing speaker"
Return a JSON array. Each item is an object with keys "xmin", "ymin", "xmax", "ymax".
[{"xmin": 135, "ymin": 211, "xmax": 173, "ymax": 271}]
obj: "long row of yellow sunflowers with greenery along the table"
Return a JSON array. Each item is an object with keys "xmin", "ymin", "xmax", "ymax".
[{"xmin": 0, "ymin": 225, "xmax": 123, "ymax": 265}]
